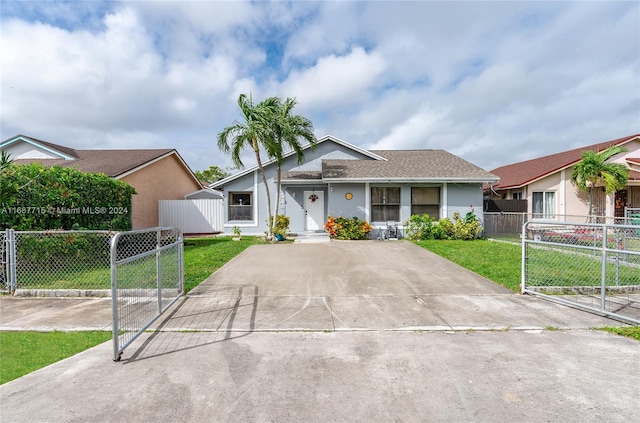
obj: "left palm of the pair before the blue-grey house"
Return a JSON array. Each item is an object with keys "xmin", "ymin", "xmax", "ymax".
[{"xmin": 218, "ymin": 94, "xmax": 280, "ymax": 238}]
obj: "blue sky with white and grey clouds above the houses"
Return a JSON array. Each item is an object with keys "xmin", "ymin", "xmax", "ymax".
[{"xmin": 0, "ymin": 0, "xmax": 640, "ymax": 175}]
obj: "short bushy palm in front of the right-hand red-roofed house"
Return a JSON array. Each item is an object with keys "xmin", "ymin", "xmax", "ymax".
[{"xmin": 571, "ymin": 146, "xmax": 629, "ymax": 216}]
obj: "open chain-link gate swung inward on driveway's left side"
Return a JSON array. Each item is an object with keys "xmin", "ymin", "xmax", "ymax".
[{"xmin": 111, "ymin": 228, "xmax": 184, "ymax": 361}]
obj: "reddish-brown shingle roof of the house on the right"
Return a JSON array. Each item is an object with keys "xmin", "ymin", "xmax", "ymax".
[{"xmin": 491, "ymin": 134, "xmax": 640, "ymax": 189}]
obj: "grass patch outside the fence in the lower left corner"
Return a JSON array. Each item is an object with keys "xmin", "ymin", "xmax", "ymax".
[{"xmin": 0, "ymin": 332, "xmax": 111, "ymax": 384}]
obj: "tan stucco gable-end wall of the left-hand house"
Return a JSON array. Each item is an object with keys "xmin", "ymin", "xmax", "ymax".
[{"xmin": 120, "ymin": 154, "xmax": 201, "ymax": 229}]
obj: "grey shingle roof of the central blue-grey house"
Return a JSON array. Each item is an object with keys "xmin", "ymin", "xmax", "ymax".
[{"xmin": 322, "ymin": 150, "xmax": 497, "ymax": 182}]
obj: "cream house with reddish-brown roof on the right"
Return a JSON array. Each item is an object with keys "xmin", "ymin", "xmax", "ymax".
[{"xmin": 485, "ymin": 134, "xmax": 640, "ymax": 219}]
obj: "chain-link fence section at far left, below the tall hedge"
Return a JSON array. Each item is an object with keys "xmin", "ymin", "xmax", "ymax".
[{"xmin": 0, "ymin": 229, "xmax": 114, "ymax": 296}]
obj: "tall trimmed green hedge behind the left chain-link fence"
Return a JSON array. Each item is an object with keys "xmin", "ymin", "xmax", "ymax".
[{"xmin": 0, "ymin": 163, "xmax": 136, "ymax": 231}]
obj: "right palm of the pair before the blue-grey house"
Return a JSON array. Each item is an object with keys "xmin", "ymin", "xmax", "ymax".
[{"xmin": 268, "ymin": 98, "xmax": 317, "ymax": 235}]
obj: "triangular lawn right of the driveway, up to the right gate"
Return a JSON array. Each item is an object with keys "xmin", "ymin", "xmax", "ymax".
[{"xmin": 416, "ymin": 240, "xmax": 521, "ymax": 292}]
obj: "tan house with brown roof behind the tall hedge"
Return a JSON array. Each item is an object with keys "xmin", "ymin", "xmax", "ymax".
[{"xmin": 0, "ymin": 135, "xmax": 203, "ymax": 229}]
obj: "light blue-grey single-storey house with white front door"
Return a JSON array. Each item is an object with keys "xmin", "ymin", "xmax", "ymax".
[{"xmin": 210, "ymin": 135, "xmax": 498, "ymax": 234}]
